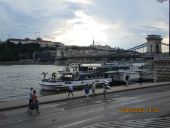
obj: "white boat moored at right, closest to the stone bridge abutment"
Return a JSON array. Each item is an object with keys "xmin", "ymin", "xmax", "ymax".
[{"xmin": 103, "ymin": 63, "xmax": 154, "ymax": 83}]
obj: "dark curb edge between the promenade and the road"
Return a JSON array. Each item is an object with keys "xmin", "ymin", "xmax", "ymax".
[{"xmin": 0, "ymin": 83, "xmax": 170, "ymax": 111}]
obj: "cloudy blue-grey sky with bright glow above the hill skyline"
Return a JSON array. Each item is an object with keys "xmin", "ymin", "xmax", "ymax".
[{"xmin": 0, "ymin": 0, "xmax": 169, "ymax": 49}]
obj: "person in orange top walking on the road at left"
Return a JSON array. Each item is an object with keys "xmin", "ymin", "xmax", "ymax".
[{"xmin": 30, "ymin": 90, "xmax": 40, "ymax": 114}]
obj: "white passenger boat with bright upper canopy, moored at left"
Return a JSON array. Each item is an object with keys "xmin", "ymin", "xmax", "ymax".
[{"xmin": 40, "ymin": 64, "xmax": 112, "ymax": 90}]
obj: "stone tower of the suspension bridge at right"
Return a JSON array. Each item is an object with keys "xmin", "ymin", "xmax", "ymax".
[{"xmin": 146, "ymin": 35, "xmax": 162, "ymax": 54}]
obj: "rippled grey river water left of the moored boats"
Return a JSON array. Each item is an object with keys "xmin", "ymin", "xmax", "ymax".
[{"xmin": 0, "ymin": 65, "xmax": 64, "ymax": 101}]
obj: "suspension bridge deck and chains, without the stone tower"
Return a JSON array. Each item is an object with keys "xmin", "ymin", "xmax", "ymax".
[{"xmin": 53, "ymin": 43, "xmax": 169, "ymax": 60}]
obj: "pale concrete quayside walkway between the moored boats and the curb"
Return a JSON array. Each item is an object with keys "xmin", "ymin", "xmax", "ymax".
[{"xmin": 0, "ymin": 82, "xmax": 170, "ymax": 111}]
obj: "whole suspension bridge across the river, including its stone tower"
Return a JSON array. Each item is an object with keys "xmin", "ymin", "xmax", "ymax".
[{"xmin": 54, "ymin": 35, "xmax": 169, "ymax": 60}]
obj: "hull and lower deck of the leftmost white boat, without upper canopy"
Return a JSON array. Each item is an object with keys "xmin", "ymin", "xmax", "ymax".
[{"xmin": 40, "ymin": 73, "xmax": 112, "ymax": 91}]
